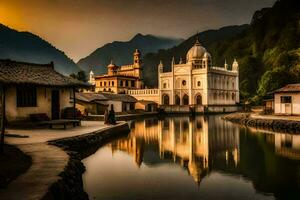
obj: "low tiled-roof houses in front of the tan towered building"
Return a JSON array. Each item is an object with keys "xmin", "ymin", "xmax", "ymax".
[{"xmin": 76, "ymin": 92, "xmax": 137, "ymax": 115}]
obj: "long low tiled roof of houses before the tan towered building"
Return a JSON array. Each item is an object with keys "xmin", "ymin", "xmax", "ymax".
[{"xmin": 76, "ymin": 92, "xmax": 137, "ymax": 103}]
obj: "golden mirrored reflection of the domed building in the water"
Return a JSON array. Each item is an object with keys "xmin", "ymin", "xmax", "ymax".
[{"xmin": 110, "ymin": 116, "xmax": 240, "ymax": 184}]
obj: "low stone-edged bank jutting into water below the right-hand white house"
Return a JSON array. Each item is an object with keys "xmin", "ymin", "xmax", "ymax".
[{"xmin": 223, "ymin": 113, "xmax": 300, "ymax": 134}]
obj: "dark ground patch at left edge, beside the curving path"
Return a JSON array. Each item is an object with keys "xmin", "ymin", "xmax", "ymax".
[{"xmin": 0, "ymin": 144, "xmax": 32, "ymax": 189}]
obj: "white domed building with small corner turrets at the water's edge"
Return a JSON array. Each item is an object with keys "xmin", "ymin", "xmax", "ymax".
[{"xmin": 158, "ymin": 40, "xmax": 239, "ymax": 112}]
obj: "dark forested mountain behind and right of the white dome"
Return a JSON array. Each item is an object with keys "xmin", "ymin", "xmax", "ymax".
[{"xmin": 143, "ymin": 0, "xmax": 300, "ymax": 104}]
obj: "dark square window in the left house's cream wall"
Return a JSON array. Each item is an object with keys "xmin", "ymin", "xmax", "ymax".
[{"xmin": 17, "ymin": 86, "xmax": 37, "ymax": 107}]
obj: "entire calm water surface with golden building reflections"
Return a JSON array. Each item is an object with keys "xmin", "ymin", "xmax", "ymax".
[{"xmin": 83, "ymin": 116, "xmax": 300, "ymax": 200}]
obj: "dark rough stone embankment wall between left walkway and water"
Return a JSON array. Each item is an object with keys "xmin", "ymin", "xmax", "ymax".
[{"xmin": 43, "ymin": 123, "xmax": 129, "ymax": 200}]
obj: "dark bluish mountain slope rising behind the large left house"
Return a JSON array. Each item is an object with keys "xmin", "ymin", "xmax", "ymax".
[{"xmin": 0, "ymin": 24, "xmax": 80, "ymax": 75}]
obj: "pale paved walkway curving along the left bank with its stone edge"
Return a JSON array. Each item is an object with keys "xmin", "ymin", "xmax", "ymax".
[{"xmin": 0, "ymin": 121, "xmax": 129, "ymax": 200}]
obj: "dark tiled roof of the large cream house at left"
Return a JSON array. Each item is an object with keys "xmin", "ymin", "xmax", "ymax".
[{"xmin": 0, "ymin": 59, "xmax": 89, "ymax": 87}]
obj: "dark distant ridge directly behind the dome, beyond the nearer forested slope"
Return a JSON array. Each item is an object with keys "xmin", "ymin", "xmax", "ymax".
[{"xmin": 143, "ymin": 24, "xmax": 250, "ymax": 87}]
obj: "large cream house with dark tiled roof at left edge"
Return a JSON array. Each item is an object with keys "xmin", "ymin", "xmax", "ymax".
[{"xmin": 0, "ymin": 60, "xmax": 89, "ymax": 122}]
